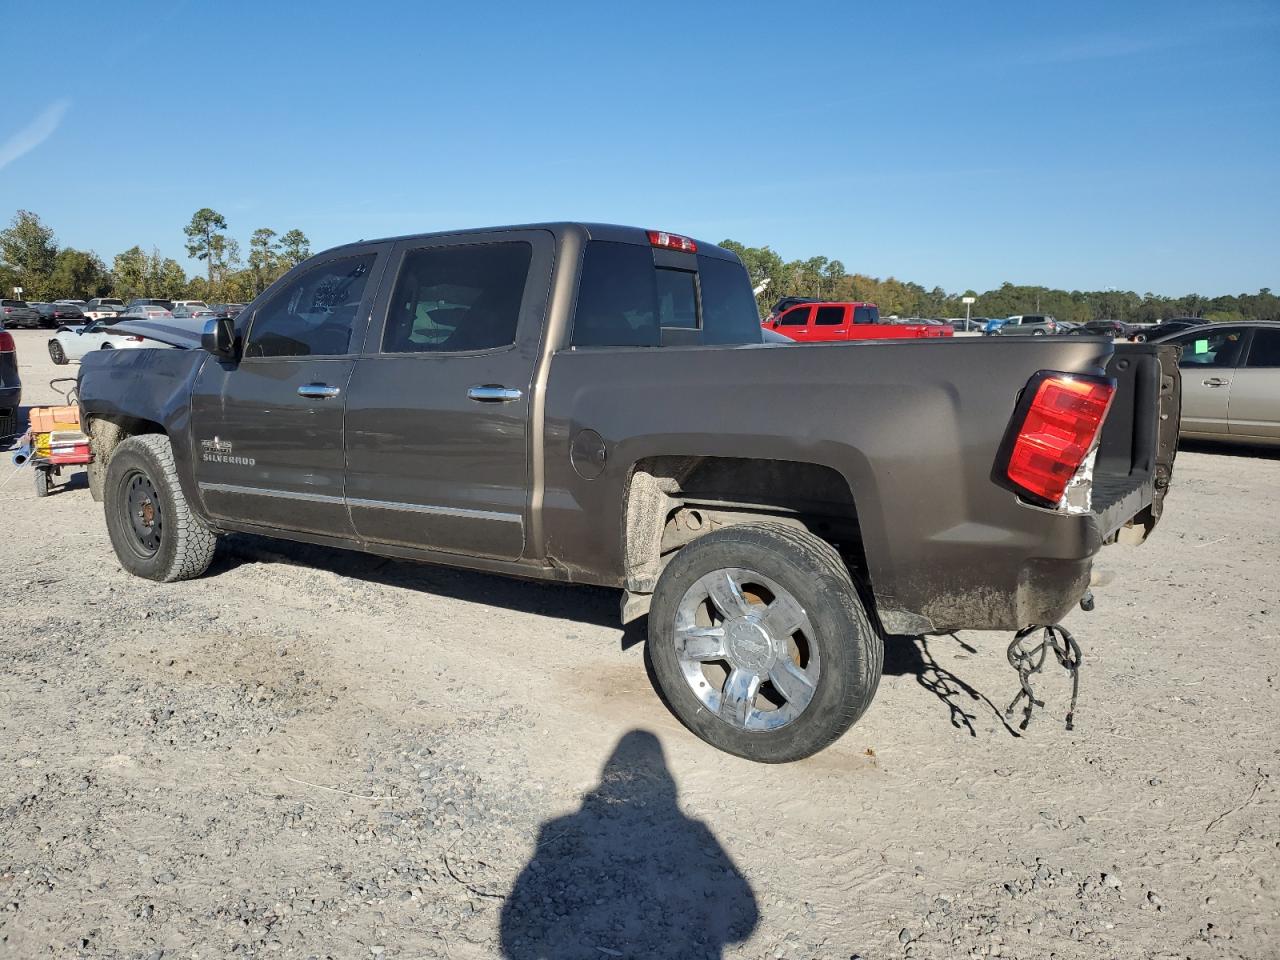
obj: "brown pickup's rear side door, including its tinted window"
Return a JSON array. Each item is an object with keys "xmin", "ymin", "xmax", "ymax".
[{"xmin": 347, "ymin": 230, "xmax": 554, "ymax": 559}]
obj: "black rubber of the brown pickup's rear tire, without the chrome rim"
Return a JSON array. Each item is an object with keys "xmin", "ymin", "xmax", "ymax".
[{"xmin": 648, "ymin": 522, "xmax": 884, "ymax": 763}]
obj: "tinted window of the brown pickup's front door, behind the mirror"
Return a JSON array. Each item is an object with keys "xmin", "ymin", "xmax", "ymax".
[{"xmin": 244, "ymin": 253, "xmax": 376, "ymax": 357}]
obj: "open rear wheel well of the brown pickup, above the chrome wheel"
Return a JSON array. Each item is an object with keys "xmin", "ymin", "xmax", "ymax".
[{"xmin": 623, "ymin": 457, "xmax": 867, "ymax": 594}]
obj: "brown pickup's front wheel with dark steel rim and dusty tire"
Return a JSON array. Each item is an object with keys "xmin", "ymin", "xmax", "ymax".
[{"xmin": 104, "ymin": 434, "xmax": 218, "ymax": 584}]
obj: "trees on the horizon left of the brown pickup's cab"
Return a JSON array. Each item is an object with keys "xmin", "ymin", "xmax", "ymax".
[{"xmin": 0, "ymin": 207, "xmax": 311, "ymax": 303}]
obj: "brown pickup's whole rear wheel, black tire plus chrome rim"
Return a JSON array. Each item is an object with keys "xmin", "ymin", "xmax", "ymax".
[{"xmin": 649, "ymin": 524, "xmax": 884, "ymax": 763}]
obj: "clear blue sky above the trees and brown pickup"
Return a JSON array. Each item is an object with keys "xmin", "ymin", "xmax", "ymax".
[{"xmin": 0, "ymin": 0, "xmax": 1280, "ymax": 294}]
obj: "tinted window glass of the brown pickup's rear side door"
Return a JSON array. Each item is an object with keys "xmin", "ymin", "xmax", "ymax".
[{"xmin": 383, "ymin": 241, "xmax": 534, "ymax": 353}]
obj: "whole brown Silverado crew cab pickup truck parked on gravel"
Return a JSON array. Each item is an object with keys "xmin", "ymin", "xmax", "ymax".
[{"xmin": 81, "ymin": 223, "xmax": 1179, "ymax": 762}]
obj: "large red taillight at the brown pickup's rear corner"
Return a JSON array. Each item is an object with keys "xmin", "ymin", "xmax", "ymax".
[{"xmin": 1006, "ymin": 374, "xmax": 1115, "ymax": 504}]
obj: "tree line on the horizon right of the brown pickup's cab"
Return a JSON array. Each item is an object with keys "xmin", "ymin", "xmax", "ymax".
[{"xmin": 721, "ymin": 239, "xmax": 1280, "ymax": 323}]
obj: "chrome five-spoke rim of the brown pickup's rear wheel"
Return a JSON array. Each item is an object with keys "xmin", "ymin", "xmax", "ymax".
[{"xmin": 675, "ymin": 567, "xmax": 822, "ymax": 731}]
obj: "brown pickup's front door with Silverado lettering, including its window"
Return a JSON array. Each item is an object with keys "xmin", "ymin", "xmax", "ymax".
[{"xmin": 191, "ymin": 243, "xmax": 392, "ymax": 538}]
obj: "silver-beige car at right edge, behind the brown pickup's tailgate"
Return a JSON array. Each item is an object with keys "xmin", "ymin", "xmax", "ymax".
[{"xmin": 1152, "ymin": 320, "xmax": 1280, "ymax": 447}]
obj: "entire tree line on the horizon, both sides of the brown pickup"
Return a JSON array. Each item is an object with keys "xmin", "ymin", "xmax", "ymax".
[{"xmin": 0, "ymin": 207, "xmax": 1280, "ymax": 323}]
